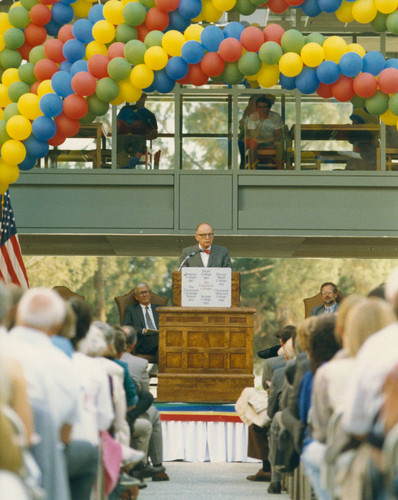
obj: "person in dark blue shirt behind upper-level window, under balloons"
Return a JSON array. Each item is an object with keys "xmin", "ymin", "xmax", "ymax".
[{"xmin": 117, "ymin": 93, "xmax": 158, "ymax": 168}]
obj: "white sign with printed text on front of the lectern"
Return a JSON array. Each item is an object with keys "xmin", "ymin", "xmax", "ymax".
[{"xmin": 181, "ymin": 267, "xmax": 231, "ymax": 307}]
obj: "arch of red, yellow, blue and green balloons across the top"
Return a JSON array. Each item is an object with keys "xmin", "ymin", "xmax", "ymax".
[{"xmin": 0, "ymin": 0, "xmax": 398, "ymax": 192}]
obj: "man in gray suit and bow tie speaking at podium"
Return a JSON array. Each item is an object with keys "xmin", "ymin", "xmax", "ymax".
[{"xmin": 180, "ymin": 222, "xmax": 231, "ymax": 267}]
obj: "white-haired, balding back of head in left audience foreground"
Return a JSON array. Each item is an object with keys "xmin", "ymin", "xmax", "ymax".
[{"xmin": 16, "ymin": 288, "xmax": 66, "ymax": 334}]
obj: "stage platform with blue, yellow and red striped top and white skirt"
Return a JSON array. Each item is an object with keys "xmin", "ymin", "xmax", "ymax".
[{"xmin": 156, "ymin": 403, "xmax": 256, "ymax": 463}]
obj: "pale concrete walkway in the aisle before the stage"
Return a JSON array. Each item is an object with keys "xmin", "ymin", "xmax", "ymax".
[{"xmin": 138, "ymin": 462, "xmax": 289, "ymax": 500}]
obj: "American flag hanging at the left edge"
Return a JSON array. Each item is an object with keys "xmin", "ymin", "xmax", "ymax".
[{"xmin": 0, "ymin": 190, "xmax": 29, "ymax": 290}]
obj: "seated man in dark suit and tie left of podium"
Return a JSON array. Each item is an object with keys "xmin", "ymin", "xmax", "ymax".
[{"xmin": 123, "ymin": 283, "xmax": 159, "ymax": 356}]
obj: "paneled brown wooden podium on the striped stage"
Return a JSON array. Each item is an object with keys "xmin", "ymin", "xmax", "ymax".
[{"xmin": 157, "ymin": 271, "xmax": 256, "ymax": 403}]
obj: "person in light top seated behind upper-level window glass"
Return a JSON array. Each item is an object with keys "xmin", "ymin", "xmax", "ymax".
[{"xmin": 245, "ymin": 95, "xmax": 283, "ymax": 169}]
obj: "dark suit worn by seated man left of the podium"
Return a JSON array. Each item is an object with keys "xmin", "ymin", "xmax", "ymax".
[{"xmin": 123, "ymin": 303, "xmax": 159, "ymax": 354}]
